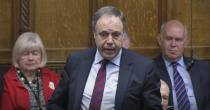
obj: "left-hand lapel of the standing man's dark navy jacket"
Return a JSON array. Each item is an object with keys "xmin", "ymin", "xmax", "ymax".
[{"xmin": 73, "ymin": 50, "xmax": 96, "ymax": 110}]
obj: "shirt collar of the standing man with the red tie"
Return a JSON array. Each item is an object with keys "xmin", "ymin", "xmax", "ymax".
[{"xmin": 94, "ymin": 49, "xmax": 122, "ymax": 66}]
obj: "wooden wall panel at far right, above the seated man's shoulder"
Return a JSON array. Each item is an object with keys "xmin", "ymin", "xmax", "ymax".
[{"xmin": 192, "ymin": 0, "xmax": 210, "ymax": 46}]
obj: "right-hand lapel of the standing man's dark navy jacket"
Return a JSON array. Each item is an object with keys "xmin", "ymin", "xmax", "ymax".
[{"xmin": 115, "ymin": 49, "xmax": 132, "ymax": 110}]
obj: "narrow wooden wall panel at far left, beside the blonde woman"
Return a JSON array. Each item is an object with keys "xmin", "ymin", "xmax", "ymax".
[{"xmin": 0, "ymin": 0, "xmax": 12, "ymax": 63}]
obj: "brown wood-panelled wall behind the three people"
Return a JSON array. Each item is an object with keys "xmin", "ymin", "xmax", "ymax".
[{"xmin": 0, "ymin": 0, "xmax": 210, "ymax": 73}]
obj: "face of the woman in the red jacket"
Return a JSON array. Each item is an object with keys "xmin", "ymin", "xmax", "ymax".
[{"xmin": 18, "ymin": 47, "xmax": 42, "ymax": 72}]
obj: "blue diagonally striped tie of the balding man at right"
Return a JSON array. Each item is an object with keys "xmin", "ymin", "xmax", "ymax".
[{"xmin": 171, "ymin": 62, "xmax": 190, "ymax": 110}]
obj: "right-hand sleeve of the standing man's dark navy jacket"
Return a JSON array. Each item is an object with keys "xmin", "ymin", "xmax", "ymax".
[{"xmin": 120, "ymin": 60, "xmax": 162, "ymax": 110}]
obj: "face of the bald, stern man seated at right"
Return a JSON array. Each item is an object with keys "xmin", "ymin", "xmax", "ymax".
[{"xmin": 158, "ymin": 22, "xmax": 187, "ymax": 62}]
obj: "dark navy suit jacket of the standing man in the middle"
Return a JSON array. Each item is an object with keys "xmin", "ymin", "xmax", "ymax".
[{"xmin": 48, "ymin": 48, "xmax": 162, "ymax": 110}]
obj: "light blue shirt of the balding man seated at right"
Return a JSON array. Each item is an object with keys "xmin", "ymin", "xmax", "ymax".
[{"xmin": 163, "ymin": 56, "xmax": 198, "ymax": 110}]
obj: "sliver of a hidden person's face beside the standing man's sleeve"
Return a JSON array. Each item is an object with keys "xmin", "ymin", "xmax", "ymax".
[{"xmin": 160, "ymin": 80, "xmax": 169, "ymax": 110}]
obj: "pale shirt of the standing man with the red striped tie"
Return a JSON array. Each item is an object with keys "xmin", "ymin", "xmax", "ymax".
[{"xmin": 81, "ymin": 49, "xmax": 122, "ymax": 110}]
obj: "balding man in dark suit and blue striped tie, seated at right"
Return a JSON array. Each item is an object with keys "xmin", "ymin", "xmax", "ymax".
[{"xmin": 154, "ymin": 20, "xmax": 210, "ymax": 110}]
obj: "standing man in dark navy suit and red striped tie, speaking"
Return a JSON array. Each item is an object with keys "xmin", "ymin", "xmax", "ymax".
[{"xmin": 48, "ymin": 7, "xmax": 162, "ymax": 110}]
